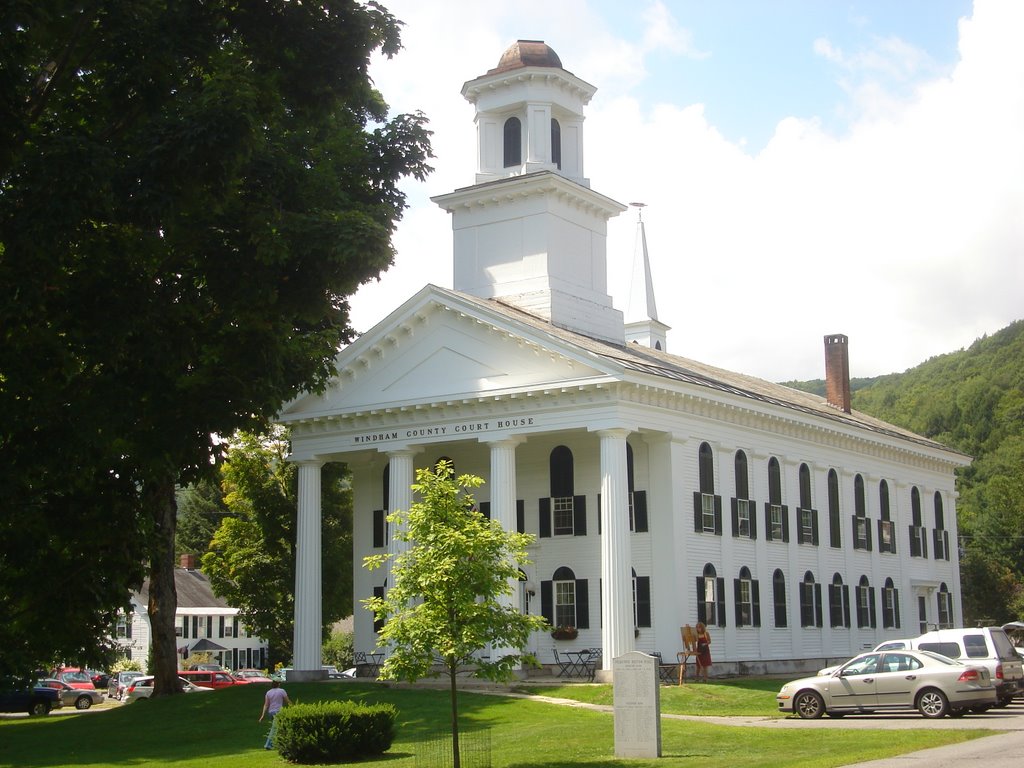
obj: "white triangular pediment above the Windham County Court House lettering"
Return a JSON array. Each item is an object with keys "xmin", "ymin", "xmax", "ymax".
[{"xmin": 283, "ymin": 288, "xmax": 608, "ymax": 421}]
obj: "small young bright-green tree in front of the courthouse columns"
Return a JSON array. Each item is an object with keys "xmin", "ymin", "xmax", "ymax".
[{"xmin": 365, "ymin": 461, "xmax": 547, "ymax": 768}]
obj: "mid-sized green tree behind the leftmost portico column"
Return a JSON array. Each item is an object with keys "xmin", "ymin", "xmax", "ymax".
[{"xmin": 203, "ymin": 427, "xmax": 352, "ymax": 663}]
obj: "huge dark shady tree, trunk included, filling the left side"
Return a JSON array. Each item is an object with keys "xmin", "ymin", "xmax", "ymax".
[{"xmin": 0, "ymin": 0, "xmax": 429, "ymax": 695}]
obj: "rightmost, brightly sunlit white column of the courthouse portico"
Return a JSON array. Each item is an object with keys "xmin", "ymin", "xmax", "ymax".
[{"xmin": 598, "ymin": 429, "xmax": 635, "ymax": 680}]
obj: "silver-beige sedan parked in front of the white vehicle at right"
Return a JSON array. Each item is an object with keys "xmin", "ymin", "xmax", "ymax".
[{"xmin": 775, "ymin": 649, "xmax": 996, "ymax": 719}]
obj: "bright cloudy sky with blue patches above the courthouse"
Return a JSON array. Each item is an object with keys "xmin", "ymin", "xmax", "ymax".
[{"xmin": 350, "ymin": 0, "xmax": 1024, "ymax": 381}]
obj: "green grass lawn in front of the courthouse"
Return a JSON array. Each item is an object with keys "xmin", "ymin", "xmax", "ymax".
[{"xmin": 0, "ymin": 682, "xmax": 988, "ymax": 768}]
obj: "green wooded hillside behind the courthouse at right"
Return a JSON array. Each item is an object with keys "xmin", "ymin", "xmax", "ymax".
[{"xmin": 791, "ymin": 321, "xmax": 1024, "ymax": 626}]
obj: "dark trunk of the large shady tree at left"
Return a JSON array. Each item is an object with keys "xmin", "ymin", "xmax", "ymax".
[{"xmin": 144, "ymin": 473, "xmax": 181, "ymax": 696}]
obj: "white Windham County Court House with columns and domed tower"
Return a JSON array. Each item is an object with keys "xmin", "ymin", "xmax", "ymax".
[{"xmin": 281, "ymin": 41, "xmax": 969, "ymax": 676}]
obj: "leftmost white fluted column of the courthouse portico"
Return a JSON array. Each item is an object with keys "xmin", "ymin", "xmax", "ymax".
[{"xmin": 289, "ymin": 460, "xmax": 325, "ymax": 680}]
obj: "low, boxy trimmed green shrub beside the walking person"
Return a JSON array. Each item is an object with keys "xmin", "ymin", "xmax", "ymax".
[{"xmin": 273, "ymin": 701, "xmax": 398, "ymax": 765}]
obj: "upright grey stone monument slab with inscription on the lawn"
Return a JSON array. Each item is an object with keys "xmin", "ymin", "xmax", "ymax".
[{"xmin": 611, "ymin": 651, "xmax": 662, "ymax": 758}]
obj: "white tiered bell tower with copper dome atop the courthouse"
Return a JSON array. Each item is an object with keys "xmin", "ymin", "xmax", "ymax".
[{"xmin": 431, "ymin": 40, "xmax": 626, "ymax": 344}]
